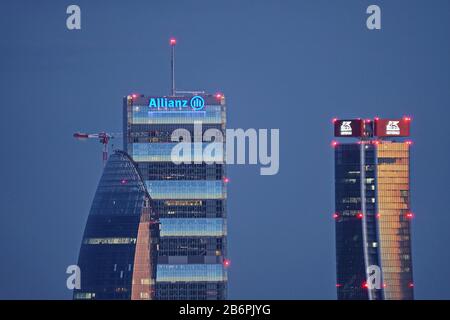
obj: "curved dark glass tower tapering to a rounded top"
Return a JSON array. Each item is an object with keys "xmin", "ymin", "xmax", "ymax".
[{"xmin": 73, "ymin": 151, "xmax": 159, "ymax": 300}]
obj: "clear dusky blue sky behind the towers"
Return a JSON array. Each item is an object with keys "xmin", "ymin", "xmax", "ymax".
[{"xmin": 0, "ymin": 0, "xmax": 450, "ymax": 299}]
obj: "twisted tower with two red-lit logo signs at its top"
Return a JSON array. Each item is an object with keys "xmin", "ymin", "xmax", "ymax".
[{"xmin": 333, "ymin": 117, "xmax": 414, "ymax": 300}]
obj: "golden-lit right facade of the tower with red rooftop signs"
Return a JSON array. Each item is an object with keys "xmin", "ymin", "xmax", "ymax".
[{"xmin": 377, "ymin": 142, "xmax": 414, "ymax": 300}]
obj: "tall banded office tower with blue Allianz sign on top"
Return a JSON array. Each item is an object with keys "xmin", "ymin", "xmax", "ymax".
[{"xmin": 123, "ymin": 93, "xmax": 229, "ymax": 300}]
